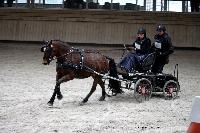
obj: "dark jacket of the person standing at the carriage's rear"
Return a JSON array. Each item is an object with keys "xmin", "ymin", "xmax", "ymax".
[{"xmin": 153, "ymin": 33, "xmax": 174, "ymax": 64}]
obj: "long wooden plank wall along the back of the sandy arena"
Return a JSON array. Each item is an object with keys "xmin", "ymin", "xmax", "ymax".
[{"xmin": 0, "ymin": 8, "xmax": 200, "ymax": 48}]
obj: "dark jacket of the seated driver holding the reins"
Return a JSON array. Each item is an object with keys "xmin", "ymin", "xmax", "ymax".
[{"xmin": 133, "ymin": 38, "xmax": 151, "ymax": 55}]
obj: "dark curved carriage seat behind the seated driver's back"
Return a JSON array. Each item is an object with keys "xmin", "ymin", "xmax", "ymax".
[{"xmin": 135, "ymin": 52, "xmax": 156, "ymax": 73}]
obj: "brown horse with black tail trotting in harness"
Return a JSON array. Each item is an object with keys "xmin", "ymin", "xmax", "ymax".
[{"xmin": 41, "ymin": 40, "xmax": 120, "ymax": 106}]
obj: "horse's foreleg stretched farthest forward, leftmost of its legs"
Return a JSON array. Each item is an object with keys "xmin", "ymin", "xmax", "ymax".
[{"xmin": 48, "ymin": 75, "xmax": 73, "ymax": 106}]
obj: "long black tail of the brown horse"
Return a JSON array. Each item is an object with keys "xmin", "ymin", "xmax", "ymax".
[{"xmin": 108, "ymin": 58, "xmax": 122, "ymax": 94}]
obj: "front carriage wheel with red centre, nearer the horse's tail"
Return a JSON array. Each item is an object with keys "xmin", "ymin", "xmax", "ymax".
[{"xmin": 134, "ymin": 78, "xmax": 152, "ymax": 103}]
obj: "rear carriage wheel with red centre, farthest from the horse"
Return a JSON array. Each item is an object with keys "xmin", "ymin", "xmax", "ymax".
[{"xmin": 163, "ymin": 80, "xmax": 180, "ymax": 100}]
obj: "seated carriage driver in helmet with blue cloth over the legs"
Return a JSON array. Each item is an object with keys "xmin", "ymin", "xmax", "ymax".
[{"xmin": 117, "ymin": 28, "xmax": 151, "ymax": 75}]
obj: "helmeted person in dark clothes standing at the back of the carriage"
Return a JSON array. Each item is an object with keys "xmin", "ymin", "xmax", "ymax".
[{"xmin": 152, "ymin": 24, "xmax": 174, "ymax": 73}]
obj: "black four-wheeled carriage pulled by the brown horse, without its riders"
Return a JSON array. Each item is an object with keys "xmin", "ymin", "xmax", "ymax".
[{"xmin": 104, "ymin": 53, "xmax": 180, "ymax": 102}]
